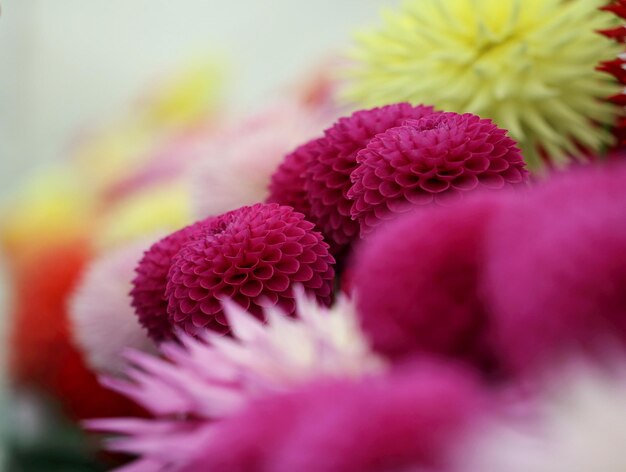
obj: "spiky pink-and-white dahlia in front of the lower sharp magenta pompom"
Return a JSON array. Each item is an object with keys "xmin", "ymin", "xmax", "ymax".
[{"xmin": 88, "ymin": 297, "xmax": 385, "ymax": 472}]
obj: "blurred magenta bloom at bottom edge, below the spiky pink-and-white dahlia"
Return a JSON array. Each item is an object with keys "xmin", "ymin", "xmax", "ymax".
[{"xmin": 181, "ymin": 362, "xmax": 485, "ymax": 472}]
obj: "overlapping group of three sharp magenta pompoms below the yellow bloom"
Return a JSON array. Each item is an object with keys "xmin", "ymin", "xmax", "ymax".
[{"xmin": 269, "ymin": 103, "xmax": 528, "ymax": 255}]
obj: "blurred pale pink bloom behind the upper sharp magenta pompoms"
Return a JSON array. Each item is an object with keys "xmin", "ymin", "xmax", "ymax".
[{"xmin": 190, "ymin": 103, "xmax": 329, "ymax": 218}]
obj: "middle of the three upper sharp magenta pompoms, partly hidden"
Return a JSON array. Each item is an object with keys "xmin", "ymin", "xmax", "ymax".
[{"xmin": 305, "ymin": 103, "xmax": 433, "ymax": 252}]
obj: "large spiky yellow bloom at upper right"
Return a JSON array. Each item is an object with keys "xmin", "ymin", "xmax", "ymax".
[{"xmin": 346, "ymin": 0, "xmax": 619, "ymax": 168}]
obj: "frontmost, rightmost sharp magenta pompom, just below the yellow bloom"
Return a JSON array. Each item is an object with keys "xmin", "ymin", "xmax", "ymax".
[{"xmin": 348, "ymin": 113, "xmax": 528, "ymax": 236}]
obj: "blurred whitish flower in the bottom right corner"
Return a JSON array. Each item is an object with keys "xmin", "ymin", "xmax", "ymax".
[{"xmin": 461, "ymin": 364, "xmax": 626, "ymax": 472}]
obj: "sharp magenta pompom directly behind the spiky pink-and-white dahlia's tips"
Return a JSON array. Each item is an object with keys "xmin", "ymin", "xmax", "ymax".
[{"xmin": 166, "ymin": 203, "xmax": 335, "ymax": 334}]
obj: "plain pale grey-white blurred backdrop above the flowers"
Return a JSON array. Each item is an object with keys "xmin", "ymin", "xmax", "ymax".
[{"xmin": 0, "ymin": 0, "xmax": 398, "ymax": 199}]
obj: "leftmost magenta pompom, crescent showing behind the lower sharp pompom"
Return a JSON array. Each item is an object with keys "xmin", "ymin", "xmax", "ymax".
[{"xmin": 130, "ymin": 218, "xmax": 210, "ymax": 342}]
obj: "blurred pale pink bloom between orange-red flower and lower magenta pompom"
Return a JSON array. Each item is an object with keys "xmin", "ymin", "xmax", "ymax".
[{"xmin": 69, "ymin": 243, "xmax": 155, "ymax": 373}]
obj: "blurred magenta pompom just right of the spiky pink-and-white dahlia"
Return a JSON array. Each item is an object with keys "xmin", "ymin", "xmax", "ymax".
[{"xmin": 351, "ymin": 198, "xmax": 499, "ymax": 366}]
